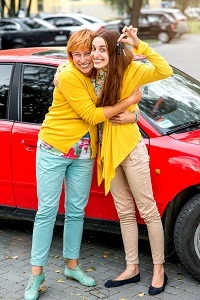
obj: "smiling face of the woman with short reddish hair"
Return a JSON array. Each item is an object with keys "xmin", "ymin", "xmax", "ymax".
[{"xmin": 72, "ymin": 49, "xmax": 93, "ymax": 76}]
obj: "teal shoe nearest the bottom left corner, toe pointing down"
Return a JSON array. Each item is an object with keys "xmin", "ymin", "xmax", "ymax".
[{"xmin": 24, "ymin": 273, "xmax": 45, "ymax": 300}]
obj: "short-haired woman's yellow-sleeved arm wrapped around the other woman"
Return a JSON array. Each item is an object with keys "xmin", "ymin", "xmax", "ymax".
[{"xmin": 58, "ymin": 68, "xmax": 142, "ymax": 125}]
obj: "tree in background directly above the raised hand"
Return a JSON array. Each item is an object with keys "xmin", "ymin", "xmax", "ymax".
[{"xmin": 104, "ymin": 0, "xmax": 144, "ymax": 27}]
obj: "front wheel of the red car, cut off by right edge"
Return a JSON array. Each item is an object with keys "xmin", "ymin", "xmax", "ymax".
[{"xmin": 174, "ymin": 194, "xmax": 200, "ymax": 280}]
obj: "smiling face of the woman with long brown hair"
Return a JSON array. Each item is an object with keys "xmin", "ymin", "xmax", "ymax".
[{"xmin": 91, "ymin": 36, "xmax": 109, "ymax": 71}]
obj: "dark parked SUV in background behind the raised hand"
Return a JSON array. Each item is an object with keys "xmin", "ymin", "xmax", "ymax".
[{"xmin": 105, "ymin": 12, "xmax": 177, "ymax": 43}]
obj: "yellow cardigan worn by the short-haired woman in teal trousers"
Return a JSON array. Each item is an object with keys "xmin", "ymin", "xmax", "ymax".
[{"xmin": 38, "ymin": 63, "xmax": 106, "ymax": 157}]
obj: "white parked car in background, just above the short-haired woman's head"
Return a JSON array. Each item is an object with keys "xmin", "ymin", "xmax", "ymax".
[{"xmin": 41, "ymin": 13, "xmax": 106, "ymax": 32}]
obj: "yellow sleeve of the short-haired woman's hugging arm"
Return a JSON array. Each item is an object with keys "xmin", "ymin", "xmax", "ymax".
[{"xmin": 58, "ymin": 68, "xmax": 106, "ymax": 125}]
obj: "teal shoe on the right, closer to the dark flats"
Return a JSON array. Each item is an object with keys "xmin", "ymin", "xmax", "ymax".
[{"xmin": 64, "ymin": 266, "xmax": 96, "ymax": 286}]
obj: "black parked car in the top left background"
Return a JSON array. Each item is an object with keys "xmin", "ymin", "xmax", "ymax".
[{"xmin": 0, "ymin": 17, "xmax": 70, "ymax": 49}]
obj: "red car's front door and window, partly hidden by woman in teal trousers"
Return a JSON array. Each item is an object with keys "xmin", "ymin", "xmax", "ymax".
[{"xmin": 11, "ymin": 64, "xmax": 55, "ymax": 210}]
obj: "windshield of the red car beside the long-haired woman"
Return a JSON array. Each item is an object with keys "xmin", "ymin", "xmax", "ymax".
[{"xmin": 139, "ymin": 68, "xmax": 200, "ymax": 133}]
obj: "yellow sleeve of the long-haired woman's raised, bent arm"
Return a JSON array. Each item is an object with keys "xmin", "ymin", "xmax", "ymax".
[{"xmin": 134, "ymin": 41, "xmax": 173, "ymax": 86}]
